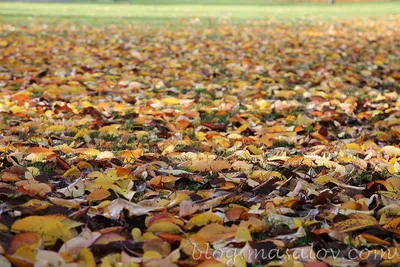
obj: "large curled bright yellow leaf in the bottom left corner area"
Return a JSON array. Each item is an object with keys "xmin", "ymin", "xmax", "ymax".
[{"xmin": 11, "ymin": 216, "xmax": 72, "ymax": 245}]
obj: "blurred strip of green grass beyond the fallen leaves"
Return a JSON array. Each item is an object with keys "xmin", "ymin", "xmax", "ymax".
[{"xmin": 0, "ymin": 0, "xmax": 400, "ymax": 24}]
